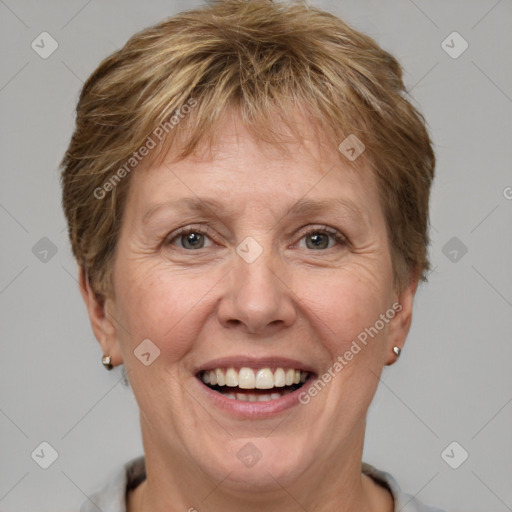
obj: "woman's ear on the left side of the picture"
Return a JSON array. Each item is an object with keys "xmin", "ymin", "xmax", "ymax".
[{"xmin": 78, "ymin": 266, "xmax": 123, "ymax": 366}]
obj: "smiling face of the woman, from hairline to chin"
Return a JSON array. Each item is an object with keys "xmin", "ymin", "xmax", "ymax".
[{"xmin": 84, "ymin": 108, "xmax": 412, "ymax": 489}]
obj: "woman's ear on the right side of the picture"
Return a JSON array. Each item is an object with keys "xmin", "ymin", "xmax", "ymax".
[{"xmin": 386, "ymin": 271, "xmax": 419, "ymax": 365}]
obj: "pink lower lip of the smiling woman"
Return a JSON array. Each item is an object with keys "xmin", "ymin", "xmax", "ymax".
[{"xmin": 196, "ymin": 377, "xmax": 314, "ymax": 419}]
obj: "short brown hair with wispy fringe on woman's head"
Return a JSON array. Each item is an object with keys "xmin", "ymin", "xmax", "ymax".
[{"xmin": 61, "ymin": 0, "xmax": 435, "ymax": 296}]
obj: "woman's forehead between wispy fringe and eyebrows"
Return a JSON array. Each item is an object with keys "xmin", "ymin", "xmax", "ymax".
[{"xmin": 124, "ymin": 109, "xmax": 377, "ymax": 225}]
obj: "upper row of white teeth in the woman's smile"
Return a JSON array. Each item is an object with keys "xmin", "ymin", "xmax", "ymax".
[{"xmin": 201, "ymin": 367, "xmax": 309, "ymax": 389}]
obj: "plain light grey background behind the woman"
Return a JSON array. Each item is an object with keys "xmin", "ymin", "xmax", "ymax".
[{"xmin": 0, "ymin": 0, "xmax": 512, "ymax": 512}]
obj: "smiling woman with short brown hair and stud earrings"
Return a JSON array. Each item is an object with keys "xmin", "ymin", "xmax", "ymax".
[{"xmin": 62, "ymin": 0, "xmax": 444, "ymax": 512}]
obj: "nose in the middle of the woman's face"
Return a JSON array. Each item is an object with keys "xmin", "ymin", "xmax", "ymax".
[{"xmin": 218, "ymin": 247, "xmax": 297, "ymax": 335}]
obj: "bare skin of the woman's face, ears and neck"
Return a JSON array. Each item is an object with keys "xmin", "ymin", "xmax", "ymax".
[{"xmin": 81, "ymin": 113, "xmax": 417, "ymax": 512}]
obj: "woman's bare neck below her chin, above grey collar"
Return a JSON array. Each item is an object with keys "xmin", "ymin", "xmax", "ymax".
[{"xmin": 127, "ymin": 425, "xmax": 393, "ymax": 512}]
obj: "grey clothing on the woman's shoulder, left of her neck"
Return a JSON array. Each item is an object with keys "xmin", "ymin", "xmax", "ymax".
[{"xmin": 80, "ymin": 456, "xmax": 146, "ymax": 512}]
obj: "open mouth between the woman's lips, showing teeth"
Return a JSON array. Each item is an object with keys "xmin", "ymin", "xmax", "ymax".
[{"xmin": 197, "ymin": 366, "xmax": 314, "ymax": 402}]
